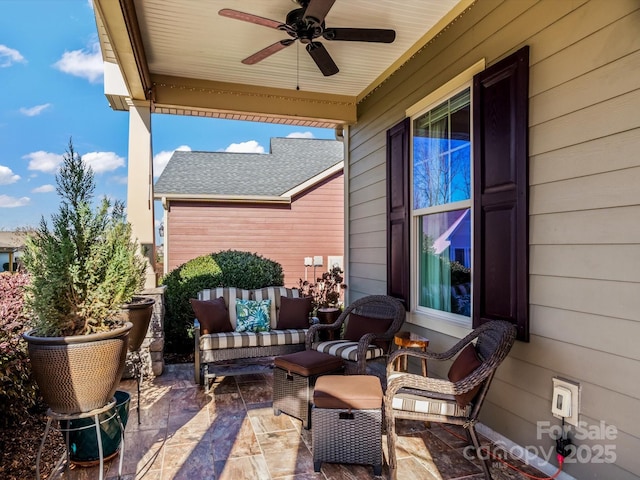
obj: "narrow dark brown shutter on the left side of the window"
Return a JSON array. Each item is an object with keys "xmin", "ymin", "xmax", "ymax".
[{"xmin": 387, "ymin": 118, "xmax": 411, "ymax": 310}]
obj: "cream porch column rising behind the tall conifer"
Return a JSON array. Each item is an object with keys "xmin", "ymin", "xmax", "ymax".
[{"xmin": 127, "ymin": 100, "xmax": 156, "ymax": 289}]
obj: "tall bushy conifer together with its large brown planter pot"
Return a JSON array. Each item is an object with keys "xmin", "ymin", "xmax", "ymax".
[{"xmin": 22, "ymin": 141, "xmax": 146, "ymax": 414}]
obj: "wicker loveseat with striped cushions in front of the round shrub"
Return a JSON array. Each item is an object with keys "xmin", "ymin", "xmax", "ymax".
[{"xmin": 192, "ymin": 287, "xmax": 311, "ymax": 386}]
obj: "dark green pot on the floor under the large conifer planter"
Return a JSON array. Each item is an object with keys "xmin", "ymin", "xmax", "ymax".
[{"xmin": 61, "ymin": 390, "xmax": 131, "ymax": 466}]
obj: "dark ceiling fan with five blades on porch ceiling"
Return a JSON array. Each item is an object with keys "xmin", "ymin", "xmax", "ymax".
[{"xmin": 218, "ymin": 0, "xmax": 396, "ymax": 77}]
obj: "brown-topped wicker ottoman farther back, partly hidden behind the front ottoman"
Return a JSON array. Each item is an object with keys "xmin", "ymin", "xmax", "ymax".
[{"xmin": 273, "ymin": 350, "xmax": 343, "ymax": 429}]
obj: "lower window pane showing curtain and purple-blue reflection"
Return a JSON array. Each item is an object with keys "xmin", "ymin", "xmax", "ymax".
[{"xmin": 418, "ymin": 209, "xmax": 471, "ymax": 317}]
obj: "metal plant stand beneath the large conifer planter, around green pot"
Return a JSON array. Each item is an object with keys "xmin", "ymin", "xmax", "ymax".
[{"xmin": 36, "ymin": 398, "xmax": 124, "ymax": 480}]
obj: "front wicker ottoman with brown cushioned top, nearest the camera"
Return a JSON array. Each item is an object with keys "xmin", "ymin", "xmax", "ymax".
[{"xmin": 311, "ymin": 375, "xmax": 382, "ymax": 475}]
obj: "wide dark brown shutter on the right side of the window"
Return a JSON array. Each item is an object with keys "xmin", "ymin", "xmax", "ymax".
[{"xmin": 472, "ymin": 46, "xmax": 529, "ymax": 341}]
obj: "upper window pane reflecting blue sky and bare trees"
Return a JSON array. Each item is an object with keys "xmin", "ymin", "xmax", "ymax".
[{"xmin": 413, "ymin": 89, "xmax": 471, "ymax": 209}]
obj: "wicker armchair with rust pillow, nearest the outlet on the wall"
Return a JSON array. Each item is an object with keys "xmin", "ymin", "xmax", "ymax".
[{"xmin": 384, "ymin": 320, "xmax": 516, "ymax": 479}]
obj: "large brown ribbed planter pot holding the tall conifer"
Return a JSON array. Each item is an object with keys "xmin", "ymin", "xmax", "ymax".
[{"xmin": 23, "ymin": 323, "xmax": 133, "ymax": 414}]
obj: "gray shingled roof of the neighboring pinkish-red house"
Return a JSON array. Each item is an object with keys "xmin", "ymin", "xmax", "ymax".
[{"xmin": 155, "ymin": 138, "xmax": 344, "ymax": 196}]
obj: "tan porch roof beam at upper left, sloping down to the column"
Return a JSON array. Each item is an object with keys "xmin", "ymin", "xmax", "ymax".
[{"xmin": 94, "ymin": 0, "xmax": 151, "ymax": 100}]
